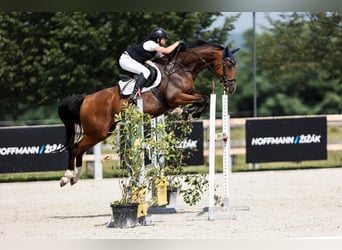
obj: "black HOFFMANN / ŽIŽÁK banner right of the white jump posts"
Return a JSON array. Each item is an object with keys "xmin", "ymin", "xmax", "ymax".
[{"xmin": 246, "ymin": 117, "xmax": 327, "ymax": 163}]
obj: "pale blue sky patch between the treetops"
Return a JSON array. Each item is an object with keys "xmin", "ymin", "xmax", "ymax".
[{"xmin": 213, "ymin": 12, "xmax": 288, "ymax": 33}]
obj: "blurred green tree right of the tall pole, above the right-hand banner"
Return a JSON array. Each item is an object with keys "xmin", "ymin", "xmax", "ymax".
[{"xmin": 258, "ymin": 13, "xmax": 342, "ymax": 114}]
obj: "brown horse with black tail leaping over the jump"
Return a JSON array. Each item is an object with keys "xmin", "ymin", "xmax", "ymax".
[{"xmin": 58, "ymin": 41, "xmax": 239, "ymax": 187}]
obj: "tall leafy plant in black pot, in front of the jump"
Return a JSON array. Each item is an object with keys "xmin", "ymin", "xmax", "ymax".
[{"xmin": 111, "ymin": 105, "xmax": 150, "ymax": 228}]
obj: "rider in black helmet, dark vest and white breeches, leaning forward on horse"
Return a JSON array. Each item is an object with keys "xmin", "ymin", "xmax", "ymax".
[{"xmin": 119, "ymin": 28, "xmax": 180, "ymax": 103}]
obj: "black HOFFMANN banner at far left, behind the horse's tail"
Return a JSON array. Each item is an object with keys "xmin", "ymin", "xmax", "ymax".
[{"xmin": 0, "ymin": 125, "xmax": 68, "ymax": 173}]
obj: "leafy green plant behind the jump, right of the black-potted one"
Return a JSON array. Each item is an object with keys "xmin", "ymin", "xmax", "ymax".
[{"xmin": 154, "ymin": 112, "xmax": 208, "ymax": 206}]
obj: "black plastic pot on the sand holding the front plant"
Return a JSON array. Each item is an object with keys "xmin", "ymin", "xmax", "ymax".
[{"xmin": 111, "ymin": 203, "xmax": 139, "ymax": 228}]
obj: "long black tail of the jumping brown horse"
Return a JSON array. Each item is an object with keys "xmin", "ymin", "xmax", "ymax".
[{"xmin": 58, "ymin": 95, "xmax": 84, "ymax": 150}]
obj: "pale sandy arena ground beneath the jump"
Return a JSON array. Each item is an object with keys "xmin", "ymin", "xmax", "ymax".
[{"xmin": 0, "ymin": 168, "xmax": 342, "ymax": 239}]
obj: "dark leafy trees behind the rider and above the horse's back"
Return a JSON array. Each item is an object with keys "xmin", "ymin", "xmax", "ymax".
[{"xmin": 0, "ymin": 12, "xmax": 238, "ymax": 120}]
